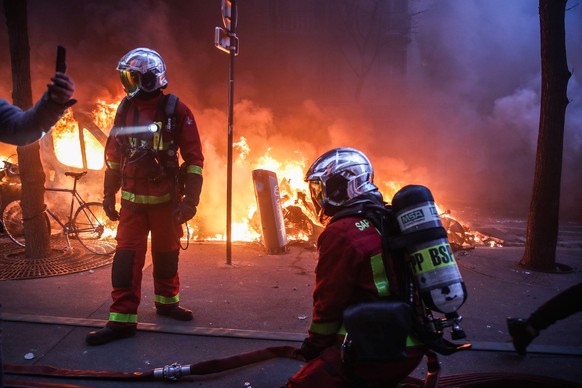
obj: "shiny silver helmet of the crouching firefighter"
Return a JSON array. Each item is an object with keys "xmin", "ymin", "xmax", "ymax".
[{"xmin": 305, "ymin": 148, "xmax": 378, "ymax": 224}]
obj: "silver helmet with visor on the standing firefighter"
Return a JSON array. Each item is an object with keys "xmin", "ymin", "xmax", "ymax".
[{"xmin": 117, "ymin": 47, "xmax": 168, "ymax": 98}]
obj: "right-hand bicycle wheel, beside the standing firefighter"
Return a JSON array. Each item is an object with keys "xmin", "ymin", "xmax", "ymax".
[{"xmin": 73, "ymin": 202, "xmax": 117, "ymax": 255}]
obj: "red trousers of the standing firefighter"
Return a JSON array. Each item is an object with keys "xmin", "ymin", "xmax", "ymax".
[{"xmin": 109, "ymin": 203, "xmax": 182, "ymax": 325}]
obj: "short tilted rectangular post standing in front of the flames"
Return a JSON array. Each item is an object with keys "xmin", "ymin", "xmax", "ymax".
[{"xmin": 253, "ymin": 170, "xmax": 287, "ymax": 254}]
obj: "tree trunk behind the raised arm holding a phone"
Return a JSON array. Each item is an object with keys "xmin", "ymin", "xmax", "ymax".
[{"xmin": 4, "ymin": 0, "xmax": 50, "ymax": 259}]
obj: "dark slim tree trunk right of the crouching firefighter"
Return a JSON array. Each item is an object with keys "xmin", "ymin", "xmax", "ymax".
[{"xmin": 519, "ymin": 0, "xmax": 571, "ymax": 271}]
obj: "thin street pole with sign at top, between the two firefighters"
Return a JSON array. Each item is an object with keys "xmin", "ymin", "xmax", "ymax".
[{"xmin": 214, "ymin": 0, "xmax": 238, "ymax": 265}]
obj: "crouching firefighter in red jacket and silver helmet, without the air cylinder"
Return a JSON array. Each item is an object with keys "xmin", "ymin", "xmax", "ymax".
[{"xmin": 287, "ymin": 148, "xmax": 426, "ymax": 387}]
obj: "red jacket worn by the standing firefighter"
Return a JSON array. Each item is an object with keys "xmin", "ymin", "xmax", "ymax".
[{"xmin": 104, "ymin": 91, "xmax": 204, "ymax": 209}]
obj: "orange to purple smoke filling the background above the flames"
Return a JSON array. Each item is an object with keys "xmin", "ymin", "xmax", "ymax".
[{"xmin": 0, "ymin": 0, "xmax": 582, "ymax": 232}]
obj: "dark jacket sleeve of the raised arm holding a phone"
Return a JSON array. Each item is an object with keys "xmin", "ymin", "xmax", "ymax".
[{"xmin": 0, "ymin": 93, "xmax": 67, "ymax": 146}]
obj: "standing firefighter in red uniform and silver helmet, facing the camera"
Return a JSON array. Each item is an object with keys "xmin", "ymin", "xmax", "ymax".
[{"xmin": 86, "ymin": 48, "xmax": 204, "ymax": 345}]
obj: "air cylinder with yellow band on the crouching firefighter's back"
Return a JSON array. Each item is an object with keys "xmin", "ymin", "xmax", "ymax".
[{"xmin": 392, "ymin": 185, "xmax": 467, "ymax": 314}]
